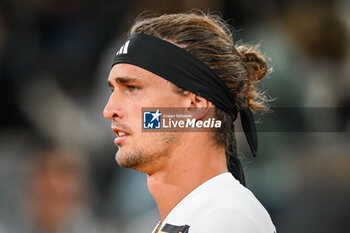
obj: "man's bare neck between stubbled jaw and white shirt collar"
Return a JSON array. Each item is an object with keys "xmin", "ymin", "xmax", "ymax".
[{"xmin": 147, "ymin": 134, "xmax": 227, "ymax": 221}]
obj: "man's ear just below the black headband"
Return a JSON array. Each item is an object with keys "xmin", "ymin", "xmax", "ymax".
[{"xmin": 187, "ymin": 93, "xmax": 213, "ymax": 120}]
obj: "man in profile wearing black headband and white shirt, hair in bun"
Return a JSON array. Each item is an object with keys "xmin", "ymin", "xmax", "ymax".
[{"xmin": 104, "ymin": 13, "xmax": 275, "ymax": 233}]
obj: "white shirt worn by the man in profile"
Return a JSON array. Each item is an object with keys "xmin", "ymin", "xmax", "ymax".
[{"xmin": 153, "ymin": 172, "xmax": 276, "ymax": 233}]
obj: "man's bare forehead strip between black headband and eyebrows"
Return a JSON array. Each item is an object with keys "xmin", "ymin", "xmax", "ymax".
[{"xmin": 108, "ymin": 63, "xmax": 169, "ymax": 83}]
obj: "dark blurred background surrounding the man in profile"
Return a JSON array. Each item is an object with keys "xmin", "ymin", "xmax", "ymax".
[{"xmin": 0, "ymin": 0, "xmax": 350, "ymax": 233}]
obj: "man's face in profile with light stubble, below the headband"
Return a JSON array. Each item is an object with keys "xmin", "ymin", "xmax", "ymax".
[{"xmin": 104, "ymin": 63, "xmax": 188, "ymax": 172}]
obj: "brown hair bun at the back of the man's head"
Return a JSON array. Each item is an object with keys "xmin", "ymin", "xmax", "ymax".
[{"xmin": 237, "ymin": 45, "xmax": 268, "ymax": 81}]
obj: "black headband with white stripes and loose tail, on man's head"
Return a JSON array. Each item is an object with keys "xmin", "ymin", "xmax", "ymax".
[{"xmin": 112, "ymin": 33, "xmax": 258, "ymax": 166}]
